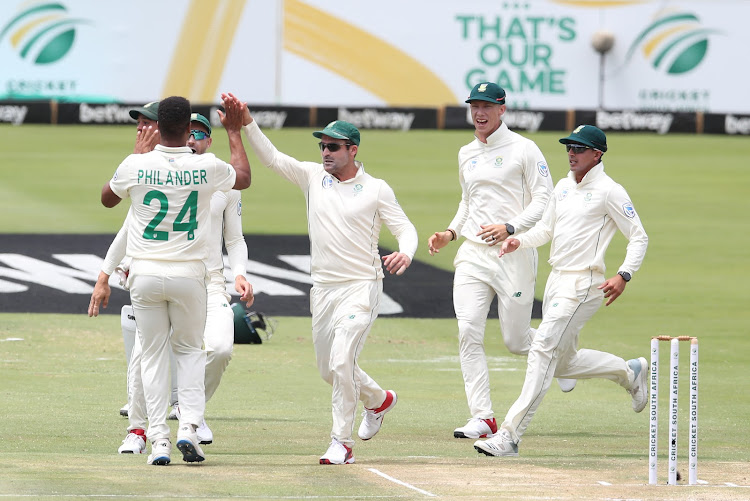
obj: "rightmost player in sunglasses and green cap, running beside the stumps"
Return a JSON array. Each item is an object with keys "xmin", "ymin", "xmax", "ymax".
[{"xmin": 474, "ymin": 125, "xmax": 649, "ymax": 456}]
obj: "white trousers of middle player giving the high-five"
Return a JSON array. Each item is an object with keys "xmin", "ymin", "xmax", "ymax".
[{"xmin": 310, "ymin": 280, "xmax": 386, "ymax": 447}]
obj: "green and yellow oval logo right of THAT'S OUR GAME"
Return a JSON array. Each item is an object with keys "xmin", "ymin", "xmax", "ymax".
[{"xmin": 625, "ymin": 9, "xmax": 719, "ymax": 75}]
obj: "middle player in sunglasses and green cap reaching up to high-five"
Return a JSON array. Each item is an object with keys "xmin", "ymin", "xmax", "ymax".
[{"xmin": 244, "ymin": 111, "xmax": 418, "ymax": 464}]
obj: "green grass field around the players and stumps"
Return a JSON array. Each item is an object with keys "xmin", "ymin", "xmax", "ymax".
[{"xmin": 0, "ymin": 125, "xmax": 750, "ymax": 499}]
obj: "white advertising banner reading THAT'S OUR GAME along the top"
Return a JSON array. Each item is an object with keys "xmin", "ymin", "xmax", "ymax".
[{"xmin": 0, "ymin": 0, "xmax": 750, "ymax": 114}]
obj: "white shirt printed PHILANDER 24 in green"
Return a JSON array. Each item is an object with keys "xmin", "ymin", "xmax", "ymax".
[{"xmin": 109, "ymin": 145, "xmax": 236, "ymax": 261}]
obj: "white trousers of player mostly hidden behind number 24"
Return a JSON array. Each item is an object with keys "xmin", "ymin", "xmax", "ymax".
[{"xmin": 123, "ymin": 286, "xmax": 234, "ymax": 431}]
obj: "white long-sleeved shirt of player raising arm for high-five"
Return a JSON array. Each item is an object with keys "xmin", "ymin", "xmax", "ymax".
[{"xmin": 244, "ymin": 121, "xmax": 418, "ymax": 285}]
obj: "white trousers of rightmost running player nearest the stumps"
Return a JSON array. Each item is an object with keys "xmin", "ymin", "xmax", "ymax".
[{"xmin": 502, "ymin": 270, "xmax": 634, "ymax": 442}]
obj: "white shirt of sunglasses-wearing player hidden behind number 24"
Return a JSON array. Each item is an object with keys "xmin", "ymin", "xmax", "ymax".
[{"xmin": 102, "ymin": 190, "xmax": 247, "ymax": 290}]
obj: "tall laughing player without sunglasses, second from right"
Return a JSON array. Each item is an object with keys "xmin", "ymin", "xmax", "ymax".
[{"xmin": 428, "ymin": 82, "xmax": 552, "ymax": 438}]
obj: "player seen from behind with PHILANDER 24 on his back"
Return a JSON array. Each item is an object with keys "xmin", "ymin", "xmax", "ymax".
[{"xmin": 89, "ymin": 94, "xmax": 250, "ymax": 465}]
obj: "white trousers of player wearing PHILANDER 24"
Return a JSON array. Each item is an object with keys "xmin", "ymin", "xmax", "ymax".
[{"xmin": 130, "ymin": 259, "xmax": 206, "ymax": 442}]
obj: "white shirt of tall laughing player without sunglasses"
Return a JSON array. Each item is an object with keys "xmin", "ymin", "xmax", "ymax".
[{"xmin": 448, "ymin": 123, "xmax": 552, "ymax": 239}]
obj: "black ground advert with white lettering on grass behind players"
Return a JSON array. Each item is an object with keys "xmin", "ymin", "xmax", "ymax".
[{"xmin": 0, "ymin": 235, "xmax": 541, "ymax": 318}]
